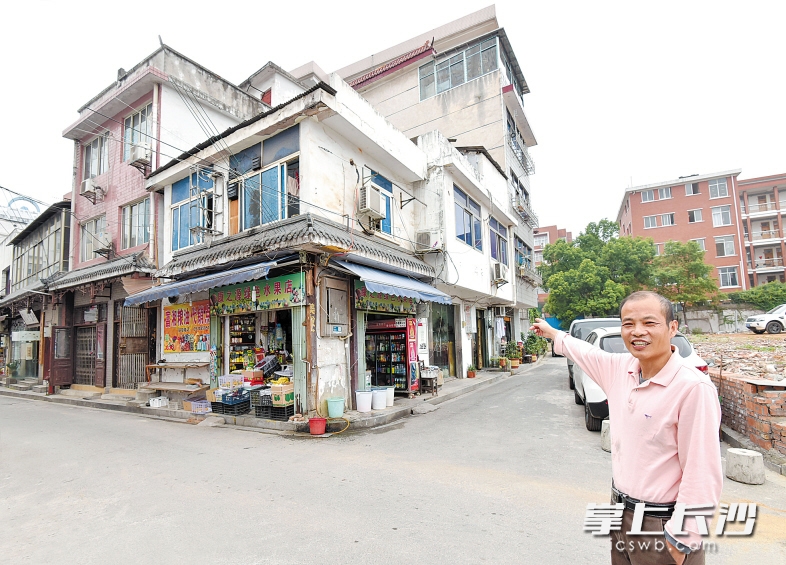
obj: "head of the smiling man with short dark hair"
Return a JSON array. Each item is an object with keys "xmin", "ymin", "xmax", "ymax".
[{"xmin": 620, "ymin": 297, "xmax": 677, "ymax": 361}]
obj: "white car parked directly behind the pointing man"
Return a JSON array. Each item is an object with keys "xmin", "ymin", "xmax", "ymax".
[{"xmin": 573, "ymin": 326, "xmax": 709, "ymax": 432}]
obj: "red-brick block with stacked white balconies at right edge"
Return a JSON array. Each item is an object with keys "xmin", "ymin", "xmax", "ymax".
[{"xmin": 738, "ymin": 174, "xmax": 786, "ymax": 288}]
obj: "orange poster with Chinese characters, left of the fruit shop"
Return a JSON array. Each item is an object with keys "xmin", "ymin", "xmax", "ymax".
[{"xmin": 164, "ymin": 300, "xmax": 210, "ymax": 353}]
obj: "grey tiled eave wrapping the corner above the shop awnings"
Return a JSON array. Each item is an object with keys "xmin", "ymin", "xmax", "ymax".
[{"xmin": 155, "ymin": 214, "xmax": 434, "ymax": 278}]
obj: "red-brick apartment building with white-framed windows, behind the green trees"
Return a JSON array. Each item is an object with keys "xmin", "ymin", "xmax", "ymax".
[{"xmin": 617, "ymin": 170, "xmax": 744, "ymax": 292}]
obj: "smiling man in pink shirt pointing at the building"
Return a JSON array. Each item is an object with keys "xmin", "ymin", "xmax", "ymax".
[{"xmin": 531, "ymin": 291, "xmax": 723, "ymax": 565}]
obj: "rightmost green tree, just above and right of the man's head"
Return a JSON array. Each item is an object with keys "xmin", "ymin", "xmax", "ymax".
[{"xmin": 652, "ymin": 241, "xmax": 718, "ymax": 326}]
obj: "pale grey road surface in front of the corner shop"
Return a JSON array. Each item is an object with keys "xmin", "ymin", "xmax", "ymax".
[{"xmin": 0, "ymin": 358, "xmax": 786, "ymax": 565}]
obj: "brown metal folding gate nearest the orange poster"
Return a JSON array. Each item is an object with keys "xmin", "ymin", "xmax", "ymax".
[{"xmin": 115, "ymin": 307, "xmax": 150, "ymax": 389}]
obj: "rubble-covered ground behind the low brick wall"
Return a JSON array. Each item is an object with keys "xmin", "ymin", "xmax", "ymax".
[{"xmin": 693, "ymin": 336, "xmax": 786, "ymax": 381}]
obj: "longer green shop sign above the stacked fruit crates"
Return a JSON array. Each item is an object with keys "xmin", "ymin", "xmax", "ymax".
[{"xmin": 210, "ymin": 273, "xmax": 306, "ymax": 316}]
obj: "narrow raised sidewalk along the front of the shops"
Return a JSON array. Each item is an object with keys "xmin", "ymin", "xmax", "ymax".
[{"xmin": 0, "ymin": 357, "xmax": 545, "ymax": 435}]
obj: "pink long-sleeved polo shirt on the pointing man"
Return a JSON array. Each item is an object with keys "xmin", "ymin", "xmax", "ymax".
[{"xmin": 554, "ymin": 332, "xmax": 723, "ymax": 544}]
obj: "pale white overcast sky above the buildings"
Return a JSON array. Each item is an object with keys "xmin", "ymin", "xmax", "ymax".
[{"xmin": 0, "ymin": 0, "xmax": 786, "ymax": 235}]
